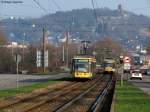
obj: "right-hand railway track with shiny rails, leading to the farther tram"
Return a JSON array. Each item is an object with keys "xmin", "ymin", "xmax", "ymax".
[{"xmin": 55, "ymin": 76, "xmax": 114, "ymax": 112}]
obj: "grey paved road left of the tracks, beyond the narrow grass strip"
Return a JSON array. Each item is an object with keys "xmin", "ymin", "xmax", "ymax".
[{"xmin": 0, "ymin": 73, "xmax": 71, "ymax": 90}]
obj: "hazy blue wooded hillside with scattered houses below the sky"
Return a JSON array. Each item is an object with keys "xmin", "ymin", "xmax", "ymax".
[{"xmin": 0, "ymin": 8, "xmax": 150, "ymax": 47}]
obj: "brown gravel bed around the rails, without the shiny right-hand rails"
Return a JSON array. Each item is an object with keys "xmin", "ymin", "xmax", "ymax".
[{"xmin": 0, "ymin": 75, "xmax": 115, "ymax": 112}]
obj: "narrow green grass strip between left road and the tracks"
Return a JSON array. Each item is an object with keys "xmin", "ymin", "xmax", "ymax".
[{"xmin": 0, "ymin": 81, "xmax": 60, "ymax": 98}]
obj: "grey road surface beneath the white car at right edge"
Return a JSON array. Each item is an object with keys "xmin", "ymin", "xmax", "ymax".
[{"xmin": 129, "ymin": 75, "xmax": 150, "ymax": 95}]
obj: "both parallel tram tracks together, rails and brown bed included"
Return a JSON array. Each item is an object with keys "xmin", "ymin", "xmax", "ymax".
[{"xmin": 2, "ymin": 75, "xmax": 114, "ymax": 112}]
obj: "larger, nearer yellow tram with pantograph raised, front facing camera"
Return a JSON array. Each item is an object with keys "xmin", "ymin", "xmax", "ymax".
[{"xmin": 72, "ymin": 56, "xmax": 96, "ymax": 79}]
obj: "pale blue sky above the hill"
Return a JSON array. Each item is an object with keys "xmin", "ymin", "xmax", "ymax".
[{"xmin": 0, "ymin": 0, "xmax": 150, "ymax": 18}]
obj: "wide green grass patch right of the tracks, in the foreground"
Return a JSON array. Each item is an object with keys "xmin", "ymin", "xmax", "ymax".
[{"xmin": 115, "ymin": 82, "xmax": 150, "ymax": 112}]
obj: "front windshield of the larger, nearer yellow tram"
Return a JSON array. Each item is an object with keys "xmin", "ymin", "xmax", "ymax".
[{"xmin": 75, "ymin": 61, "xmax": 89, "ymax": 72}]
